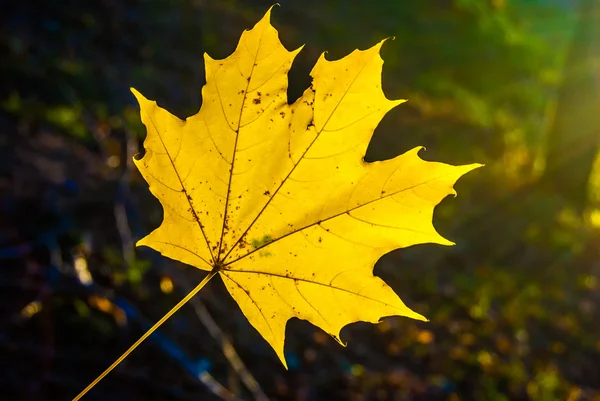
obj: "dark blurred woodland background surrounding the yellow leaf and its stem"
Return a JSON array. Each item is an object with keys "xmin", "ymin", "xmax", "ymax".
[{"xmin": 0, "ymin": 0, "xmax": 600, "ymax": 401}]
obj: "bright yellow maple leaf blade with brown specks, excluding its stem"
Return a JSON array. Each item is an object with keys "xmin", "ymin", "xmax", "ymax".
[{"xmin": 132, "ymin": 10, "xmax": 480, "ymax": 365}]
